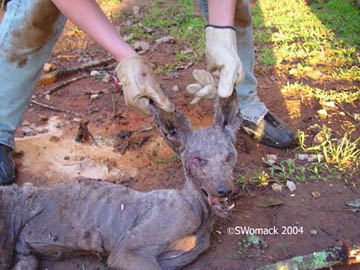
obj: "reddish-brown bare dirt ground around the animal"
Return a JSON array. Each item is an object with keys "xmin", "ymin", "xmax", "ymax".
[{"xmin": 6, "ymin": 1, "xmax": 360, "ymax": 270}]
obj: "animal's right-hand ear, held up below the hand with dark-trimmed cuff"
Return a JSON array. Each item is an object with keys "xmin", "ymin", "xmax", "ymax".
[{"xmin": 213, "ymin": 89, "xmax": 242, "ymax": 141}]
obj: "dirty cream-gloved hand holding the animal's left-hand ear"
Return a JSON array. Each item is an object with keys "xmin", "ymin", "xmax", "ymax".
[{"xmin": 115, "ymin": 56, "xmax": 175, "ymax": 116}]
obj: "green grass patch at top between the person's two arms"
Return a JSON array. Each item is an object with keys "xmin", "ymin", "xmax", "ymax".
[{"xmin": 116, "ymin": 0, "xmax": 205, "ymax": 75}]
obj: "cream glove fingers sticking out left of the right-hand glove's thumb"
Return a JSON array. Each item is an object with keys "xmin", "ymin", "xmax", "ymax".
[{"xmin": 186, "ymin": 69, "xmax": 218, "ymax": 104}]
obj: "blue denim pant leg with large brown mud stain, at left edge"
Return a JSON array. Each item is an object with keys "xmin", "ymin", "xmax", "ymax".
[{"xmin": 0, "ymin": 0, "xmax": 66, "ymax": 148}]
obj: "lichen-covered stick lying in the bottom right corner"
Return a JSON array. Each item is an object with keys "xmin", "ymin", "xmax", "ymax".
[{"xmin": 256, "ymin": 244, "xmax": 360, "ymax": 270}]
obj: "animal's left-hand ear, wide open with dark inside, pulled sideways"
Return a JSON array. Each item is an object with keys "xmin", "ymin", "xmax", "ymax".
[{"xmin": 149, "ymin": 104, "xmax": 192, "ymax": 156}]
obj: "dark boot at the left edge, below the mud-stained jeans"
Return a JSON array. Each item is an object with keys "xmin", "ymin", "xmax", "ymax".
[{"xmin": 0, "ymin": 144, "xmax": 16, "ymax": 185}]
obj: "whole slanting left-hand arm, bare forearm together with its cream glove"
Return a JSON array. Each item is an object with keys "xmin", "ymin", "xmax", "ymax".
[{"xmin": 52, "ymin": 0, "xmax": 174, "ymax": 115}]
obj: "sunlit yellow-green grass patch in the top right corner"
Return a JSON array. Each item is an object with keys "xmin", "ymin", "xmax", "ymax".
[{"xmin": 253, "ymin": 0, "xmax": 360, "ymax": 74}]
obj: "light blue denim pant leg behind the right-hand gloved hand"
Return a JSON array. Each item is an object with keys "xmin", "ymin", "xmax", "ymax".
[{"xmin": 198, "ymin": 0, "xmax": 267, "ymax": 122}]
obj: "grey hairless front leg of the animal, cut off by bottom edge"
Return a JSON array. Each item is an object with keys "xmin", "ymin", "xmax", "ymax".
[{"xmin": 107, "ymin": 247, "xmax": 162, "ymax": 270}]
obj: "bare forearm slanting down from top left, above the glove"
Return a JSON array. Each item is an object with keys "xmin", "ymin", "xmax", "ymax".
[{"xmin": 52, "ymin": 0, "xmax": 137, "ymax": 62}]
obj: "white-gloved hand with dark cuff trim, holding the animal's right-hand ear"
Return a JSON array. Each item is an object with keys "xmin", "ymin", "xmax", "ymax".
[{"xmin": 206, "ymin": 25, "xmax": 245, "ymax": 98}]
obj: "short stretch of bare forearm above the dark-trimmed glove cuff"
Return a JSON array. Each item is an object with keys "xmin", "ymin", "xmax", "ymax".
[{"xmin": 208, "ymin": 0, "xmax": 236, "ymax": 26}]
